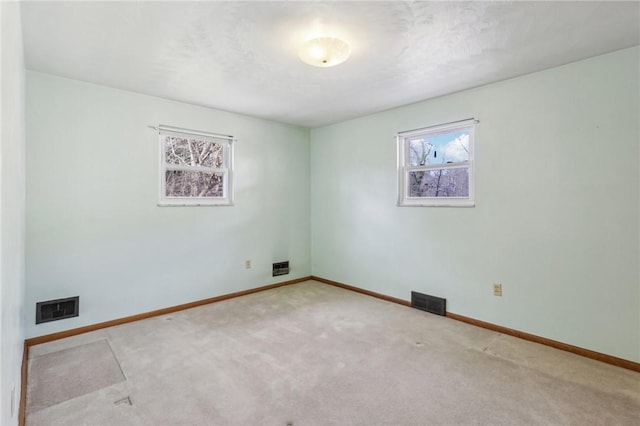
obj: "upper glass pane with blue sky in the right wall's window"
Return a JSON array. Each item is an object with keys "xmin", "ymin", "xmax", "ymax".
[{"xmin": 409, "ymin": 130, "xmax": 469, "ymax": 166}]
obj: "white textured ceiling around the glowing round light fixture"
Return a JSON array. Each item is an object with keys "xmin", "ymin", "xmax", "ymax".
[{"xmin": 22, "ymin": 1, "xmax": 640, "ymax": 127}]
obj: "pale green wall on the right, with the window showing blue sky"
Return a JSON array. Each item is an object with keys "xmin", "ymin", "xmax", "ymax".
[{"xmin": 311, "ymin": 48, "xmax": 640, "ymax": 362}]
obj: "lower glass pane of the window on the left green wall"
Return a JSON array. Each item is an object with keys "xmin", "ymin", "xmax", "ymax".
[{"xmin": 165, "ymin": 170, "xmax": 224, "ymax": 197}]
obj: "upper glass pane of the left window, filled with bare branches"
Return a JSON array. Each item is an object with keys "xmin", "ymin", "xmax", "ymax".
[{"xmin": 163, "ymin": 135, "xmax": 222, "ymax": 168}]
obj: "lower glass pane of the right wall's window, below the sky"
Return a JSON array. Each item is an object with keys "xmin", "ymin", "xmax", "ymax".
[{"xmin": 408, "ymin": 167, "xmax": 469, "ymax": 197}]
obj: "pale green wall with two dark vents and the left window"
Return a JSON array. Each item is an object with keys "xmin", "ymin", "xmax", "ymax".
[{"xmin": 25, "ymin": 72, "xmax": 310, "ymax": 337}]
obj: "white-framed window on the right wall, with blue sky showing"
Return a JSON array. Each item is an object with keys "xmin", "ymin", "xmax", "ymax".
[{"xmin": 397, "ymin": 119, "xmax": 477, "ymax": 206}]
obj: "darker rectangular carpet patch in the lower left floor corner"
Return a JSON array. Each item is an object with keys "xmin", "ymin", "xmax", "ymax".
[{"xmin": 27, "ymin": 339, "xmax": 125, "ymax": 412}]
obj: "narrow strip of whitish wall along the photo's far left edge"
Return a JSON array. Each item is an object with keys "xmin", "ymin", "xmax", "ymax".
[{"xmin": 0, "ymin": 2, "xmax": 25, "ymax": 426}]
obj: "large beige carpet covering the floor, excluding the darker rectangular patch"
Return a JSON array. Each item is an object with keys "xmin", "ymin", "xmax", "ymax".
[{"xmin": 27, "ymin": 282, "xmax": 640, "ymax": 426}]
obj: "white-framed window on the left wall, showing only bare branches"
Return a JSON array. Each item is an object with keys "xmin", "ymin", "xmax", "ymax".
[{"xmin": 157, "ymin": 126, "xmax": 234, "ymax": 206}]
